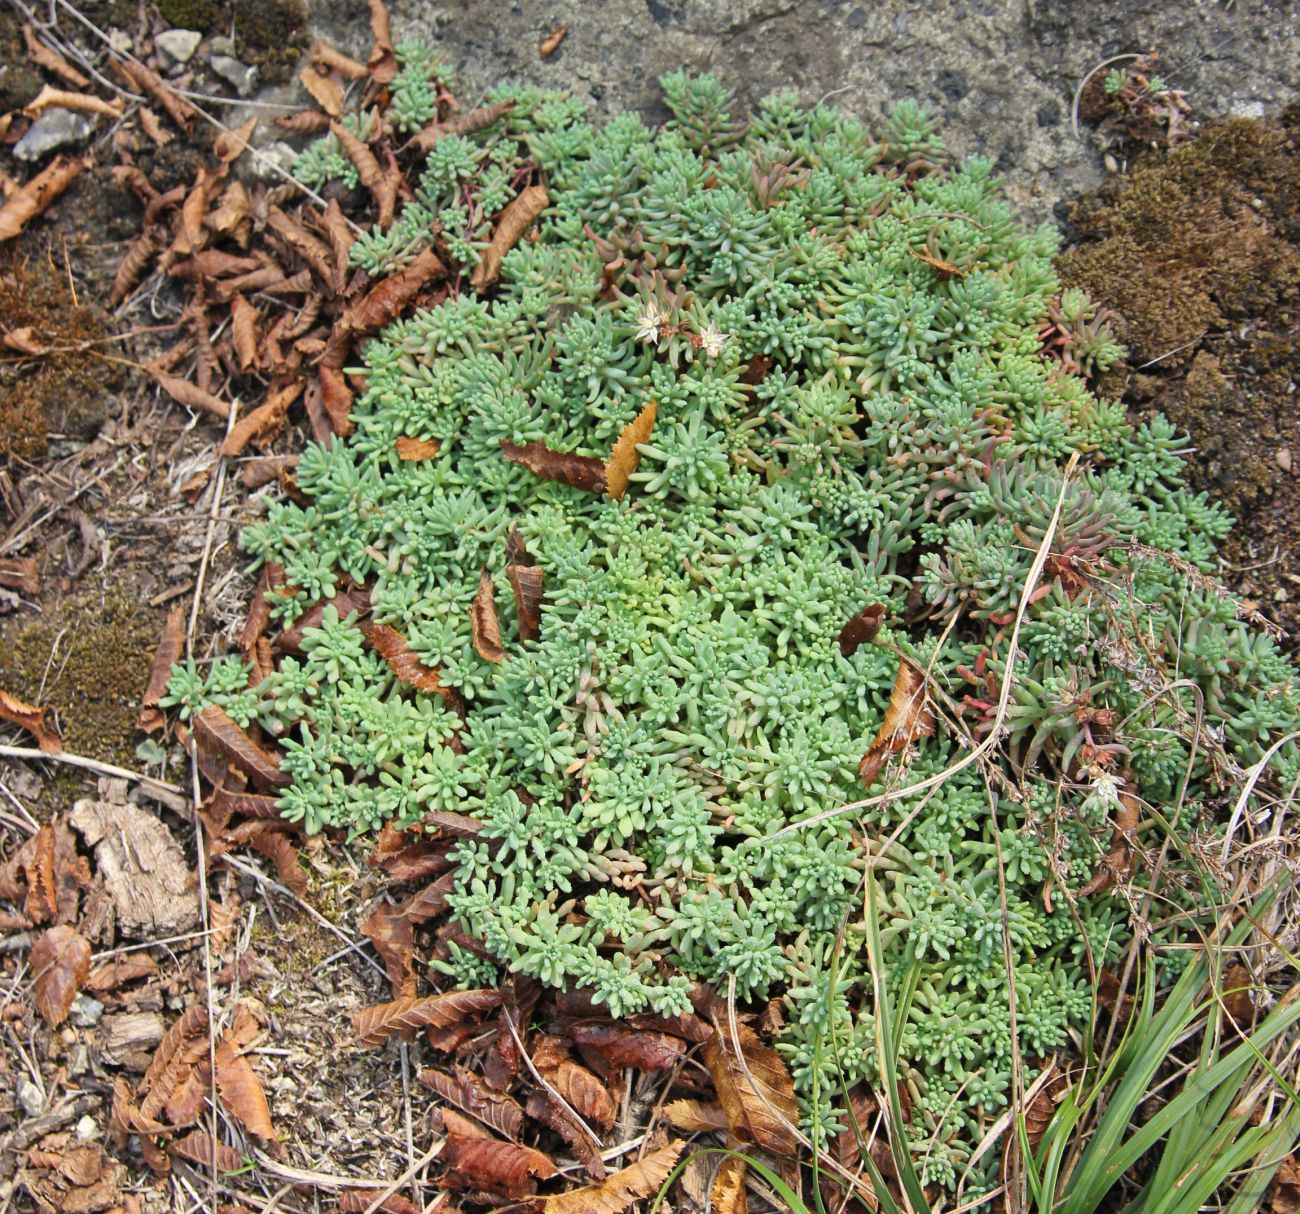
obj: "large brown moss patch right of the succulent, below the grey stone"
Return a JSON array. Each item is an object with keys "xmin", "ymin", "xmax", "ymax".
[{"xmin": 1058, "ymin": 105, "xmax": 1300, "ymax": 636}]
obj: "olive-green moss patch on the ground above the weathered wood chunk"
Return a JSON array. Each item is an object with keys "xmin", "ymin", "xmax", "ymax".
[{"xmin": 0, "ymin": 577, "xmax": 160, "ymax": 766}]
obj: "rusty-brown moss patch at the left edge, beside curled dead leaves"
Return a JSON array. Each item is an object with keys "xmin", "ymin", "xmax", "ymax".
[{"xmin": 0, "ymin": 259, "xmax": 121, "ymax": 459}]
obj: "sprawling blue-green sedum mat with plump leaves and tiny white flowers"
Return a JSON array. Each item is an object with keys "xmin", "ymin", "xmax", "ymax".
[{"xmin": 172, "ymin": 59, "xmax": 1300, "ymax": 1195}]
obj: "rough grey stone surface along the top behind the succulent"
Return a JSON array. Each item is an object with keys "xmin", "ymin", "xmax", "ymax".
[{"xmin": 312, "ymin": 0, "xmax": 1300, "ymax": 220}]
